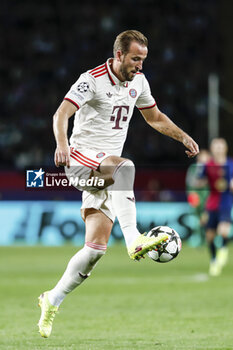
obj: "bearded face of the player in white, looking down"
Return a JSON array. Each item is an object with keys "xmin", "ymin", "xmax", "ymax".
[{"xmin": 120, "ymin": 41, "xmax": 148, "ymax": 81}]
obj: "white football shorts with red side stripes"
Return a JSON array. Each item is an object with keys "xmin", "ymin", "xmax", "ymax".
[{"xmin": 65, "ymin": 147, "xmax": 115, "ymax": 222}]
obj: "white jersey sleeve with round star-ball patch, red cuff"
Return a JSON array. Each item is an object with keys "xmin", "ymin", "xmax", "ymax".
[{"xmin": 64, "ymin": 73, "xmax": 96, "ymax": 109}]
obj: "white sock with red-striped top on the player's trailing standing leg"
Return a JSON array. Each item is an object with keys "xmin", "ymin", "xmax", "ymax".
[{"xmin": 48, "ymin": 242, "xmax": 107, "ymax": 306}]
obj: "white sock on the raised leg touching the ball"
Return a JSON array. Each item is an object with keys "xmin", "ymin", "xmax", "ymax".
[{"xmin": 112, "ymin": 160, "xmax": 140, "ymax": 247}]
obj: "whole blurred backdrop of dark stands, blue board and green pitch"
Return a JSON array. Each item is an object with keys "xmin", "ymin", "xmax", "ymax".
[{"xmin": 0, "ymin": 0, "xmax": 233, "ymax": 350}]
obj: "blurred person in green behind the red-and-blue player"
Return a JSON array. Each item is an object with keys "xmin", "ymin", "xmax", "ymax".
[{"xmin": 186, "ymin": 149, "xmax": 210, "ymax": 240}]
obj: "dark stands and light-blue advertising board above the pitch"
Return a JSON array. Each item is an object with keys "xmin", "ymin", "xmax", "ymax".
[{"xmin": 0, "ymin": 0, "xmax": 233, "ymax": 244}]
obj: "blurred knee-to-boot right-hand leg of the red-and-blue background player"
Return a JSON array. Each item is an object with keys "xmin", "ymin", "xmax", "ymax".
[{"xmin": 217, "ymin": 221, "xmax": 231, "ymax": 267}]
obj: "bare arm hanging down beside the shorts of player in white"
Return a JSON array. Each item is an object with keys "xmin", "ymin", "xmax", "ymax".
[{"xmin": 53, "ymin": 100, "xmax": 77, "ymax": 167}]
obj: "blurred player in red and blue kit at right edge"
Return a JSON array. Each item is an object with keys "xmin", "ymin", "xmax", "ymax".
[{"xmin": 201, "ymin": 138, "xmax": 233, "ymax": 276}]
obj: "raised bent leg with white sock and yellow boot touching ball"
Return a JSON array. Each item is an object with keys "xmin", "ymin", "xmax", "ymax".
[{"xmin": 99, "ymin": 156, "xmax": 168, "ymax": 260}]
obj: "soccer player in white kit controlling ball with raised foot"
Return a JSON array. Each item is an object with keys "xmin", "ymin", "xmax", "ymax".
[{"xmin": 38, "ymin": 30, "xmax": 199, "ymax": 338}]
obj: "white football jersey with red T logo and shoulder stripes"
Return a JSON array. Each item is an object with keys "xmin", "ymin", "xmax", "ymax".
[{"xmin": 65, "ymin": 59, "xmax": 156, "ymax": 156}]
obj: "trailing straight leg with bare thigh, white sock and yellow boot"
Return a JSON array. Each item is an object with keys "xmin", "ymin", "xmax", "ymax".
[{"xmin": 38, "ymin": 208, "xmax": 113, "ymax": 338}]
